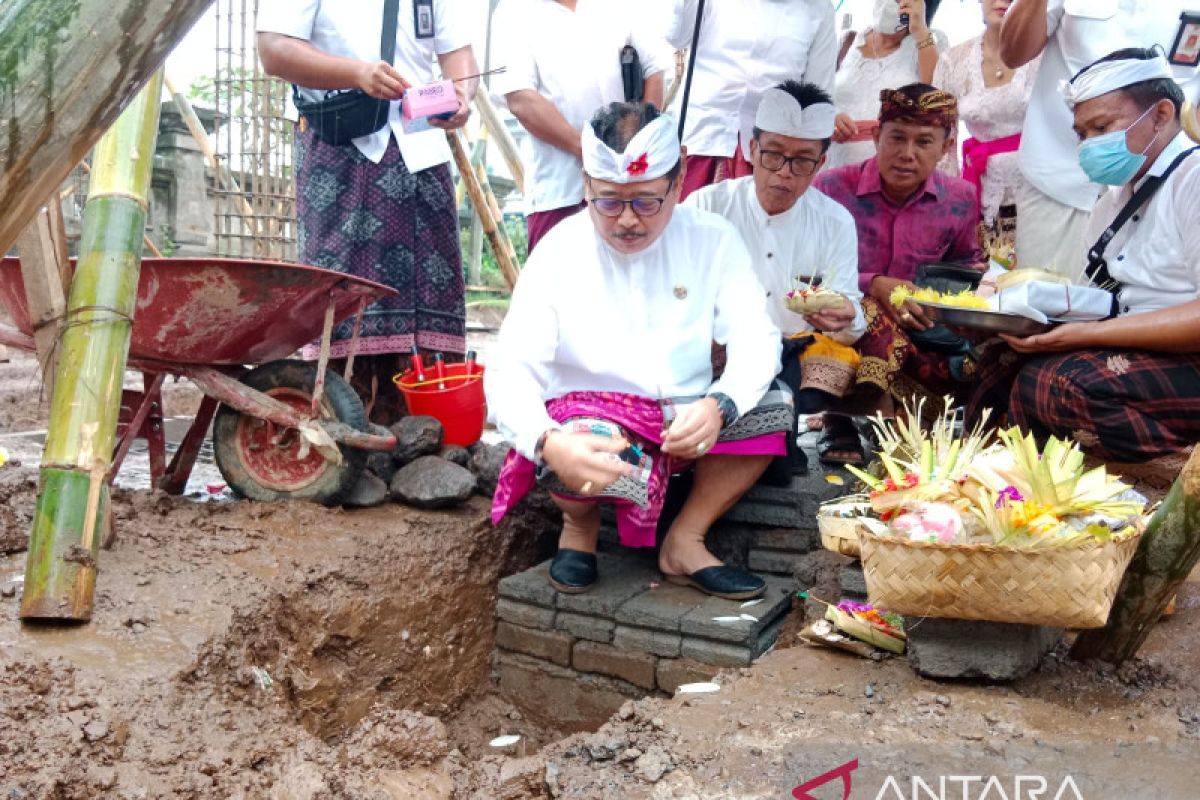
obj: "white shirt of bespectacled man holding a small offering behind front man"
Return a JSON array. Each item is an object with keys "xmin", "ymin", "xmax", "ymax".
[{"xmin": 686, "ymin": 175, "xmax": 866, "ymax": 343}]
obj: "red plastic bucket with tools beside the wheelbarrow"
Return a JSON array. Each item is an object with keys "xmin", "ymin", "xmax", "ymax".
[{"xmin": 392, "ymin": 363, "xmax": 487, "ymax": 447}]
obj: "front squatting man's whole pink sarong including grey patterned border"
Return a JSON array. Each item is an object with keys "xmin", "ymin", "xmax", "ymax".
[{"xmin": 492, "ymin": 390, "xmax": 793, "ymax": 547}]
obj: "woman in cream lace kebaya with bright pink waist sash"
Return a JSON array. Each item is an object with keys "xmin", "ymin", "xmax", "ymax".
[{"xmin": 934, "ymin": 0, "xmax": 1040, "ymax": 256}]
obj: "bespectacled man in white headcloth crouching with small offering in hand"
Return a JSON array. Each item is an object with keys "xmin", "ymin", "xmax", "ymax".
[{"xmin": 686, "ymin": 80, "xmax": 866, "ymax": 474}]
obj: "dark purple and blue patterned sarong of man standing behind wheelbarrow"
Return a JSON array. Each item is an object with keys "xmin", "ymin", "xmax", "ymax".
[{"xmin": 295, "ymin": 127, "xmax": 467, "ymax": 357}]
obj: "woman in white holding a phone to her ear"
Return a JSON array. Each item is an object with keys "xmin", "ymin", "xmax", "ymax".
[{"xmin": 824, "ymin": 0, "xmax": 948, "ymax": 169}]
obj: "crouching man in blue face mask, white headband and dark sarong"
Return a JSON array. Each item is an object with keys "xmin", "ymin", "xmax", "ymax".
[{"xmin": 968, "ymin": 48, "xmax": 1200, "ymax": 462}]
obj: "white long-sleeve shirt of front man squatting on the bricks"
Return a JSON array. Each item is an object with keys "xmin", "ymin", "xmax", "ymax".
[{"xmin": 484, "ymin": 206, "xmax": 781, "ymax": 458}]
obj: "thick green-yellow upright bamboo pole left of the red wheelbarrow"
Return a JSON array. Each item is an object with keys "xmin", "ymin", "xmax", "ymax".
[{"xmin": 20, "ymin": 73, "xmax": 162, "ymax": 621}]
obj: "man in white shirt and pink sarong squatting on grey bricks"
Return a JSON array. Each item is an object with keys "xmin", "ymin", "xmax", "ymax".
[{"xmin": 485, "ymin": 103, "xmax": 794, "ymax": 599}]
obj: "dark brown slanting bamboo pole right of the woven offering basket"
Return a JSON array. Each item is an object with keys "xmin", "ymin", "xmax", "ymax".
[{"xmin": 1070, "ymin": 446, "xmax": 1200, "ymax": 664}]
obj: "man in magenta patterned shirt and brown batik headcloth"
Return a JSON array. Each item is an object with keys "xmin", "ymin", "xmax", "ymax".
[{"xmin": 814, "ymin": 84, "xmax": 984, "ymax": 429}]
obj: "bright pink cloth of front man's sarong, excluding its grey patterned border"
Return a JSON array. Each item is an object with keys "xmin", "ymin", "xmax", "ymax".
[{"xmin": 492, "ymin": 392, "xmax": 787, "ymax": 547}]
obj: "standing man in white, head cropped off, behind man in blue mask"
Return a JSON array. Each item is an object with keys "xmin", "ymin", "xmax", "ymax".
[{"xmin": 1000, "ymin": 0, "xmax": 1200, "ymax": 278}]
